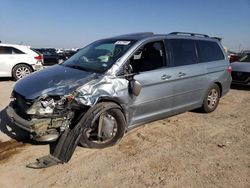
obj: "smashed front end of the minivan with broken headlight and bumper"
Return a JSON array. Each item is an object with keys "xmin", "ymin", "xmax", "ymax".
[{"xmin": 7, "ymin": 92, "xmax": 78, "ymax": 142}]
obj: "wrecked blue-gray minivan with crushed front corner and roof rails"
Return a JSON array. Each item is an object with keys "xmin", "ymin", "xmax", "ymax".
[{"xmin": 7, "ymin": 32, "xmax": 231, "ymax": 168}]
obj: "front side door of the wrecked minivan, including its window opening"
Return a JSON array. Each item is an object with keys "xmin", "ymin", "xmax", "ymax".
[{"xmin": 129, "ymin": 41, "xmax": 173, "ymax": 125}]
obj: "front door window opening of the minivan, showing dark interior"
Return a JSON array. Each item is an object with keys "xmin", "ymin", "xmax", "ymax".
[{"xmin": 130, "ymin": 41, "xmax": 165, "ymax": 72}]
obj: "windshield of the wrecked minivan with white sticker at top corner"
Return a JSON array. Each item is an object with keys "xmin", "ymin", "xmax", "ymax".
[{"xmin": 62, "ymin": 39, "xmax": 135, "ymax": 72}]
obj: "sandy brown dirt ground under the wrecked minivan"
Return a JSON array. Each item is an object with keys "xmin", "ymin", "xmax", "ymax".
[{"xmin": 0, "ymin": 80, "xmax": 250, "ymax": 188}]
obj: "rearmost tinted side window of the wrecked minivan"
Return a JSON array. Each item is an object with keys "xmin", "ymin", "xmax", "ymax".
[{"xmin": 197, "ymin": 40, "xmax": 225, "ymax": 63}]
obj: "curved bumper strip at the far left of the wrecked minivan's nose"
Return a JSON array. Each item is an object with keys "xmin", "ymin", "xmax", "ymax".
[{"xmin": 6, "ymin": 102, "xmax": 34, "ymax": 133}]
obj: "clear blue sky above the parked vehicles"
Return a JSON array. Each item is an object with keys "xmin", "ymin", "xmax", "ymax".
[{"xmin": 0, "ymin": 0, "xmax": 250, "ymax": 51}]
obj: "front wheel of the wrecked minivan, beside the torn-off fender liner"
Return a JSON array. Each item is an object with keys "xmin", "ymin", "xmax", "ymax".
[{"xmin": 79, "ymin": 102, "xmax": 126, "ymax": 148}]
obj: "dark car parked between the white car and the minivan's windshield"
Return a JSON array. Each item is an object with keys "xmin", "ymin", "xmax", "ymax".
[{"xmin": 33, "ymin": 48, "xmax": 68, "ymax": 66}]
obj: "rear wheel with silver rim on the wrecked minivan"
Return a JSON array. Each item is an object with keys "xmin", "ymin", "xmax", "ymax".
[{"xmin": 201, "ymin": 84, "xmax": 220, "ymax": 113}]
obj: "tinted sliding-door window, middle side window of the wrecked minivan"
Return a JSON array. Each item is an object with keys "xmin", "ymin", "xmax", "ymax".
[{"xmin": 167, "ymin": 39, "xmax": 198, "ymax": 66}]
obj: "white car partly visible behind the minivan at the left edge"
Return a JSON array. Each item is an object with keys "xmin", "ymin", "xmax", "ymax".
[{"xmin": 0, "ymin": 43, "xmax": 43, "ymax": 80}]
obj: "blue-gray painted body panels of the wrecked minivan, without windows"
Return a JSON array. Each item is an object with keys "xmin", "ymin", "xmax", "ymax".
[{"xmin": 10, "ymin": 35, "xmax": 231, "ymax": 131}]
